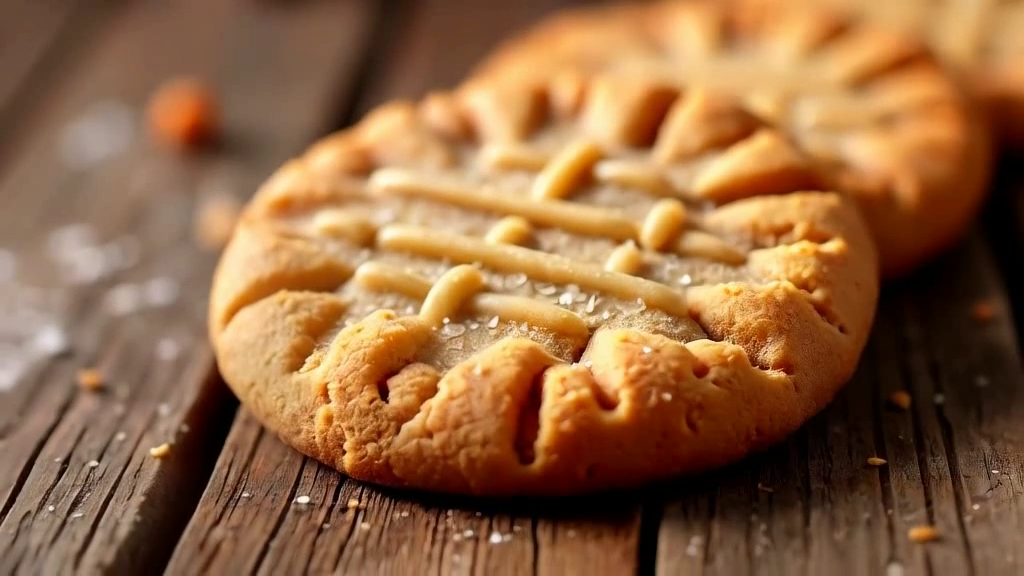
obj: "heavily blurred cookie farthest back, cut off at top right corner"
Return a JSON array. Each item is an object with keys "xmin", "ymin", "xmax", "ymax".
[{"xmin": 766, "ymin": 0, "xmax": 1024, "ymax": 150}]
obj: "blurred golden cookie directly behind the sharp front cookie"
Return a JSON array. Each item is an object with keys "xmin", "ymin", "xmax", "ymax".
[{"xmin": 471, "ymin": 1, "xmax": 991, "ymax": 278}]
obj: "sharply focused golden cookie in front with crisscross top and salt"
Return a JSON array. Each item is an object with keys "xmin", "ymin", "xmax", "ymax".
[{"xmin": 210, "ymin": 78, "xmax": 879, "ymax": 495}]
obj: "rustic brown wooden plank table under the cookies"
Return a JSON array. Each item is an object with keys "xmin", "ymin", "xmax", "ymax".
[{"xmin": 0, "ymin": 0, "xmax": 1024, "ymax": 576}]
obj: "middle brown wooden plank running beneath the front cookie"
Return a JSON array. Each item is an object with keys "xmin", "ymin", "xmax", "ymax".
[{"xmin": 168, "ymin": 0, "xmax": 640, "ymax": 575}]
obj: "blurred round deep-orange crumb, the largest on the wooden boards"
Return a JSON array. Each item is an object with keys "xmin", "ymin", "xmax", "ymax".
[{"xmin": 146, "ymin": 78, "xmax": 220, "ymax": 150}]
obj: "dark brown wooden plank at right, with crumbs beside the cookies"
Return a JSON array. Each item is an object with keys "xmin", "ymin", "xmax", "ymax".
[{"xmin": 656, "ymin": 234, "xmax": 1024, "ymax": 574}]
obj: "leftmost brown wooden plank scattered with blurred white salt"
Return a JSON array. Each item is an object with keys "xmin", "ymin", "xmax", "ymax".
[{"xmin": 0, "ymin": 0, "xmax": 371, "ymax": 573}]
